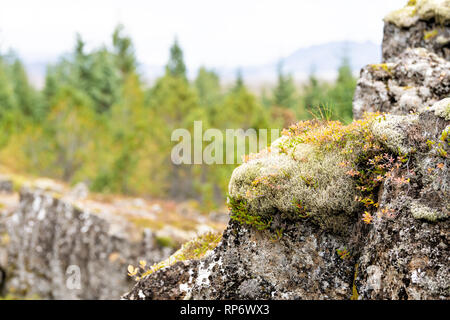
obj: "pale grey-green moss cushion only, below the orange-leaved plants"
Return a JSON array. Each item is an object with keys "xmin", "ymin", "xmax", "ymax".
[{"xmin": 229, "ymin": 144, "xmax": 358, "ymax": 234}]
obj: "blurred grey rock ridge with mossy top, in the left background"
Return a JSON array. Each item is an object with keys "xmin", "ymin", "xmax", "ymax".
[{"xmin": 0, "ymin": 171, "xmax": 227, "ymax": 299}]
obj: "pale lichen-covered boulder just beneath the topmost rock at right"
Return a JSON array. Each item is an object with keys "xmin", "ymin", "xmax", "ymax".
[{"xmin": 353, "ymin": 48, "xmax": 450, "ymax": 119}]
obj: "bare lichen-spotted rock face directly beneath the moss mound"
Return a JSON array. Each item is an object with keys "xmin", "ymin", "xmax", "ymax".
[{"xmin": 123, "ymin": 222, "xmax": 354, "ymax": 300}]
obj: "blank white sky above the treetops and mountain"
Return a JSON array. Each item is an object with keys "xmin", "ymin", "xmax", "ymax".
[{"xmin": 0, "ymin": 0, "xmax": 407, "ymax": 68}]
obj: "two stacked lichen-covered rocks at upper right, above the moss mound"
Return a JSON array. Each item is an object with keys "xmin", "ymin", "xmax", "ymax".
[{"xmin": 353, "ymin": 0, "xmax": 450, "ymax": 119}]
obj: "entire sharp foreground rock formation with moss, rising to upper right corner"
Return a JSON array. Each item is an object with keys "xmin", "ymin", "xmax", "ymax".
[{"xmin": 123, "ymin": 1, "xmax": 450, "ymax": 299}]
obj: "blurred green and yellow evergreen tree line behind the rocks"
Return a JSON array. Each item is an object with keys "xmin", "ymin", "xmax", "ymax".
[{"xmin": 0, "ymin": 25, "xmax": 356, "ymax": 210}]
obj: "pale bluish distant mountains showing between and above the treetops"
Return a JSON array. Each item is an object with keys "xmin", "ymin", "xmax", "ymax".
[{"xmin": 25, "ymin": 41, "xmax": 381, "ymax": 87}]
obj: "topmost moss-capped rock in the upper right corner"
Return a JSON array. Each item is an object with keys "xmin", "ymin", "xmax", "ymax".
[{"xmin": 382, "ymin": 0, "xmax": 450, "ymax": 61}]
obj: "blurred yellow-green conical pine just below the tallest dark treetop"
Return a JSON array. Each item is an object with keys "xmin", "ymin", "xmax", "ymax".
[{"xmin": 92, "ymin": 74, "xmax": 148, "ymax": 194}]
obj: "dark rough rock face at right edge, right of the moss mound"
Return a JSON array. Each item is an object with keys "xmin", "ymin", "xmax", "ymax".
[{"xmin": 357, "ymin": 106, "xmax": 450, "ymax": 299}]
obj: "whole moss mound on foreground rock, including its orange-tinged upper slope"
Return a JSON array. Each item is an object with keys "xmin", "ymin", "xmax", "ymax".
[{"xmin": 229, "ymin": 115, "xmax": 392, "ymax": 233}]
